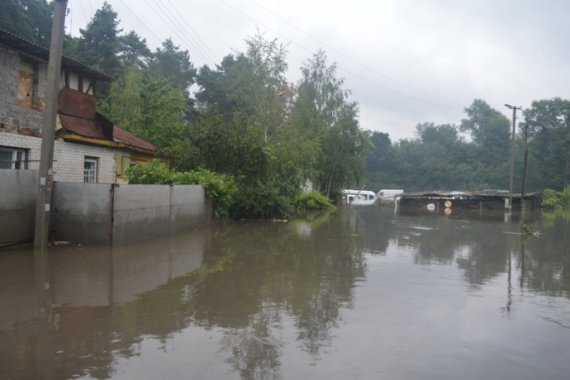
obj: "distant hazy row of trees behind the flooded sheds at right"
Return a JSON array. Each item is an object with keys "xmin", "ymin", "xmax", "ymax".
[{"xmin": 366, "ymin": 98, "xmax": 570, "ymax": 194}]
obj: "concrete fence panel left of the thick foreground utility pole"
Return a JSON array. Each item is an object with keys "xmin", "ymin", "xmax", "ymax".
[{"xmin": 0, "ymin": 169, "xmax": 38, "ymax": 246}]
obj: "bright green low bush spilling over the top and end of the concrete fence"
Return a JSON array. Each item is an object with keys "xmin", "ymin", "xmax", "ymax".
[{"xmin": 127, "ymin": 160, "xmax": 237, "ymax": 217}]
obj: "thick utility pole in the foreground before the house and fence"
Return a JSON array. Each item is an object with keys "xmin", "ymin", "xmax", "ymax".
[{"xmin": 34, "ymin": 0, "xmax": 67, "ymax": 250}]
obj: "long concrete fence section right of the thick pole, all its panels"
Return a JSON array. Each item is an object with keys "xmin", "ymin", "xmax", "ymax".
[{"xmin": 52, "ymin": 182, "xmax": 213, "ymax": 245}]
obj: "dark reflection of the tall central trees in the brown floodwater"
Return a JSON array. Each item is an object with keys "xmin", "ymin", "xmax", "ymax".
[{"xmin": 186, "ymin": 218, "xmax": 365, "ymax": 372}]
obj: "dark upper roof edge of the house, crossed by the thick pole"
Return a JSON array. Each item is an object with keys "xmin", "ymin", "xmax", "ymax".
[{"xmin": 0, "ymin": 28, "xmax": 111, "ymax": 81}]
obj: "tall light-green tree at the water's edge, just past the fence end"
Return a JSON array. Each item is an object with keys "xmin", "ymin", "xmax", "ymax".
[{"xmin": 189, "ymin": 33, "xmax": 304, "ymax": 218}]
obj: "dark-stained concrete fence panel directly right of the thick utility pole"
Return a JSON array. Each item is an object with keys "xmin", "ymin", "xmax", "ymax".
[{"xmin": 51, "ymin": 182, "xmax": 113, "ymax": 244}]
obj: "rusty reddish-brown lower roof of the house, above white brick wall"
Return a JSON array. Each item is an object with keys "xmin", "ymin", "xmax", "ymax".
[{"xmin": 59, "ymin": 113, "xmax": 157, "ymax": 153}]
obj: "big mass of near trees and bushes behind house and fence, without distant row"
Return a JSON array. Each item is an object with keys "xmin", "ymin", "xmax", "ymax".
[{"xmin": 0, "ymin": 0, "xmax": 364, "ymax": 219}]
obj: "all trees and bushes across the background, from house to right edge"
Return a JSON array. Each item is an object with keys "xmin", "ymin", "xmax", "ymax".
[{"xmin": 0, "ymin": 0, "xmax": 570, "ymax": 218}]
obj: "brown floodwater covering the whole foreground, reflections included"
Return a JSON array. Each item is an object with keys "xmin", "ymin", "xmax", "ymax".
[{"xmin": 0, "ymin": 206, "xmax": 570, "ymax": 380}]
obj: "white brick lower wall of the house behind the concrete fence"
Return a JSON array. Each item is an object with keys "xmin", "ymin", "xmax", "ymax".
[{"xmin": 0, "ymin": 132, "xmax": 116, "ymax": 183}]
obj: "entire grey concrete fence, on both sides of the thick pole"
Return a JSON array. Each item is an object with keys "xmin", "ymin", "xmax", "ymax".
[{"xmin": 0, "ymin": 170, "xmax": 213, "ymax": 246}]
